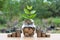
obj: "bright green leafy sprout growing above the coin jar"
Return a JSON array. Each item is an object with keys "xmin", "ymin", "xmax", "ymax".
[{"xmin": 23, "ymin": 6, "xmax": 36, "ymax": 19}]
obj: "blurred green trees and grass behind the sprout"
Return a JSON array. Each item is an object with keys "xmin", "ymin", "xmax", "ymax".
[{"xmin": 0, "ymin": 0, "xmax": 60, "ymax": 32}]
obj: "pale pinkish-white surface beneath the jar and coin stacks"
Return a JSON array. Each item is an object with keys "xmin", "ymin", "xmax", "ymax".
[{"xmin": 0, "ymin": 33, "xmax": 60, "ymax": 40}]
